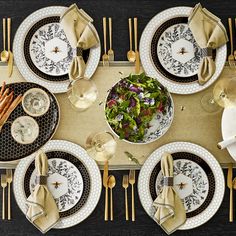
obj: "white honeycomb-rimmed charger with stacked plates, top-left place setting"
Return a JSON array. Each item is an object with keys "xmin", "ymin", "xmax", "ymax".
[{"xmin": 13, "ymin": 6, "xmax": 101, "ymax": 93}]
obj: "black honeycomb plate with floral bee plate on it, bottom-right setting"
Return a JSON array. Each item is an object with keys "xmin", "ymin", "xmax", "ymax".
[{"xmin": 149, "ymin": 152, "xmax": 215, "ymax": 218}]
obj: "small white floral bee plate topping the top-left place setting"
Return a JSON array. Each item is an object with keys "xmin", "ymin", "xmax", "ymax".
[{"xmin": 30, "ymin": 22, "xmax": 73, "ymax": 76}]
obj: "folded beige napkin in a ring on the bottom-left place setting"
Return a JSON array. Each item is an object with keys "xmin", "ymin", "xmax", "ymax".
[{"xmin": 26, "ymin": 151, "xmax": 60, "ymax": 233}]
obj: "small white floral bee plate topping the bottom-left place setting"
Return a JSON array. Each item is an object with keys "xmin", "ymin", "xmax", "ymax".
[{"xmin": 30, "ymin": 158, "xmax": 83, "ymax": 212}]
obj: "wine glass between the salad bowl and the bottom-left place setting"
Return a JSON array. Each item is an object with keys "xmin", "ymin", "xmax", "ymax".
[{"xmin": 85, "ymin": 132, "xmax": 117, "ymax": 162}]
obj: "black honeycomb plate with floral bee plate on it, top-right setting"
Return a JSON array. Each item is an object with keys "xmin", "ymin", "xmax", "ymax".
[{"xmin": 151, "ymin": 17, "xmax": 216, "ymax": 83}]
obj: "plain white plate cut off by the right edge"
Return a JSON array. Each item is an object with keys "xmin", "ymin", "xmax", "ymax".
[{"xmin": 221, "ymin": 108, "xmax": 236, "ymax": 160}]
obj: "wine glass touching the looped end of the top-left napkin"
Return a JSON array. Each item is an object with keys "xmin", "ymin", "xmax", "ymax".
[{"xmin": 67, "ymin": 78, "xmax": 98, "ymax": 111}]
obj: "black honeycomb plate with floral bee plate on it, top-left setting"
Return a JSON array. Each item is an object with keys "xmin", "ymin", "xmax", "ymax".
[{"xmin": 24, "ymin": 16, "xmax": 90, "ymax": 81}]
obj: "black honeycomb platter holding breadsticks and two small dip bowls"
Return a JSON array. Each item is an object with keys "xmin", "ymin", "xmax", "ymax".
[{"xmin": 0, "ymin": 82, "xmax": 60, "ymax": 162}]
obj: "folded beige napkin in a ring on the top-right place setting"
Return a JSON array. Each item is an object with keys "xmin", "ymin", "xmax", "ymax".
[{"xmin": 188, "ymin": 3, "xmax": 228, "ymax": 84}]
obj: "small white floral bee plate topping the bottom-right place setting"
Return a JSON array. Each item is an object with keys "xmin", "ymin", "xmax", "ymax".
[{"xmin": 156, "ymin": 159, "xmax": 209, "ymax": 213}]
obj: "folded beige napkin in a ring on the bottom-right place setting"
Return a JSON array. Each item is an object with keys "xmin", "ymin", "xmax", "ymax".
[{"xmin": 153, "ymin": 153, "xmax": 186, "ymax": 234}]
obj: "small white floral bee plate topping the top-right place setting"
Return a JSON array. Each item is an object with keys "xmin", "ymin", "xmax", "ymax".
[{"xmin": 157, "ymin": 23, "xmax": 202, "ymax": 77}]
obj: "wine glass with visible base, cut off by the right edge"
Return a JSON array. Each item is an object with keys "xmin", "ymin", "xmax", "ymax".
[{"xmin": 201, "ymin": 78, "xmax": 236, "ymax": 112}]
